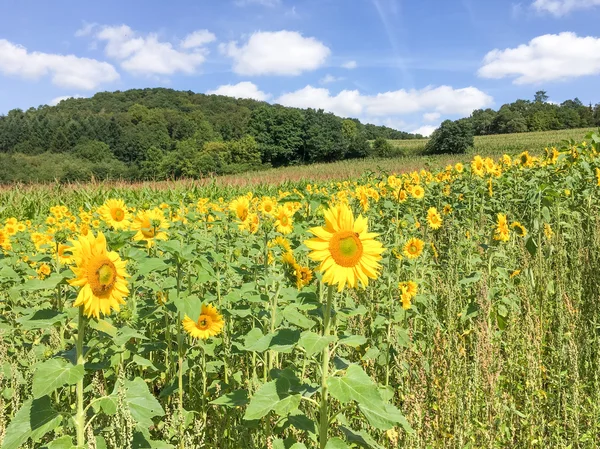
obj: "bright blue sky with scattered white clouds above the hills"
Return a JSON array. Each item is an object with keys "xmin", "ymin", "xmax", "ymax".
[{"xmin": 0, "ymin": 0, "xmax": 600, "ymax": 133}]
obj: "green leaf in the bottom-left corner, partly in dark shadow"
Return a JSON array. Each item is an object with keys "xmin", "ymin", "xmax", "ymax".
[{"xmin": 1, "ymin": 396, "xmax": 62, "ymax": 449}]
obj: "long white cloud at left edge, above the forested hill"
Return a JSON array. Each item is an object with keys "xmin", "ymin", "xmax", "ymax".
[{"xmin": 0, "ymin": 39, "xmax": 119, "ymax": 90}]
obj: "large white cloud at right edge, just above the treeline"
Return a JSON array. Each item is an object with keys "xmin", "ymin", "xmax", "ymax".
[{"xmin": 478, "ymin": 32, "xmax": 600, "ymax": 84}]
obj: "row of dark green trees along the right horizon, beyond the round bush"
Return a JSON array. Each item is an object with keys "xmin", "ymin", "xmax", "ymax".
[{"xmin": 458, "ymin": 91, "xmax": 600, "ymax": 136}]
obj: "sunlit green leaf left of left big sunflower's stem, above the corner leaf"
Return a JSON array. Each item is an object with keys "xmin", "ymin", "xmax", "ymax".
[{"xmin": 32, "ymin": 359, "xmax": 84, "ymax": 399}]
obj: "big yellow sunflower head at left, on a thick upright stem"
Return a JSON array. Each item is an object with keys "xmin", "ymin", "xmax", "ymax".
[{"xmin": 69, "ymin": 232, "xmax": 129, "ymax": 318}]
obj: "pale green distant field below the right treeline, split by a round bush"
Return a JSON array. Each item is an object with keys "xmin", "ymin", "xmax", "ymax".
[{"xmin": 389, "ymin": 128, "xmax": 596, "ymax": 155}]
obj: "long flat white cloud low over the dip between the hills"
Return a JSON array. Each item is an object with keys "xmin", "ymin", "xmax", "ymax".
[{"xmin": 276, "ymin": 85, "xmax": 493, "ymax": 117}]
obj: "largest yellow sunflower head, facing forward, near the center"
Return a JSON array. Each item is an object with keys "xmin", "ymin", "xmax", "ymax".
[{"xmin": 304, "ymin": 203, "xmax": 384, "ymax": 291}]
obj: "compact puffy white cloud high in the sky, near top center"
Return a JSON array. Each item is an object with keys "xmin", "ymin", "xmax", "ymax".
[{"xmin": 220, "ymin": 30, "xmax": 330, "ymax": 75}]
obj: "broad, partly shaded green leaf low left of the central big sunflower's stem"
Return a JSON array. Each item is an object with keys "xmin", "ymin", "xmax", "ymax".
[{"xmin": 244, "ymin": 377, "xmax": 300, "ymax": 421}]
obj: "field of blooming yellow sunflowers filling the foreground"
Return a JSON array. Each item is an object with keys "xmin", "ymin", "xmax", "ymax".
[{"xmin": 0, "ymin": 133, "xmax": 600, "ymax": 449}]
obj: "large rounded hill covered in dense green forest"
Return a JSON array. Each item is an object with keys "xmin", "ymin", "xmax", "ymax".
[{"xmin": 0, "ymin": 88, "xmax": 421, "ymax": 182}]
